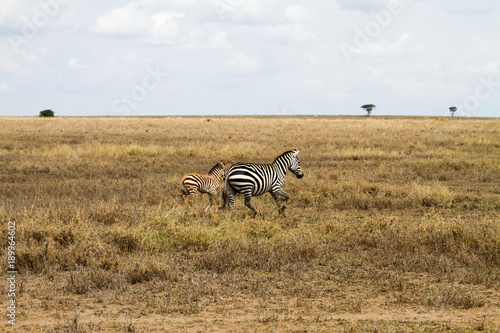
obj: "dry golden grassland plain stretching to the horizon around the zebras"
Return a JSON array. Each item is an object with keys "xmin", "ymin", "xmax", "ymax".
[{"xmin": 0, "ymin": 117, "xmax": 500, "ymax": 332}]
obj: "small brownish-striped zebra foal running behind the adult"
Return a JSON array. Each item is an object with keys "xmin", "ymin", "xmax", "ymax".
[{"xmin": 181, "ymin": 160, "xmax": 226, "ymax": 216}]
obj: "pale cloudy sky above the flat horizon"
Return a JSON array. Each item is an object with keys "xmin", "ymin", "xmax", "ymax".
[{"xmin": 0, "ymin": 0, "xmax": 500, "ymax": 117}]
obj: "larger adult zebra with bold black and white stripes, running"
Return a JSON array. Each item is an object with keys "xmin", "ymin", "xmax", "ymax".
[{"xmin": 221, "ymin": 149, "xmax": 304, "ymax": 216}]
